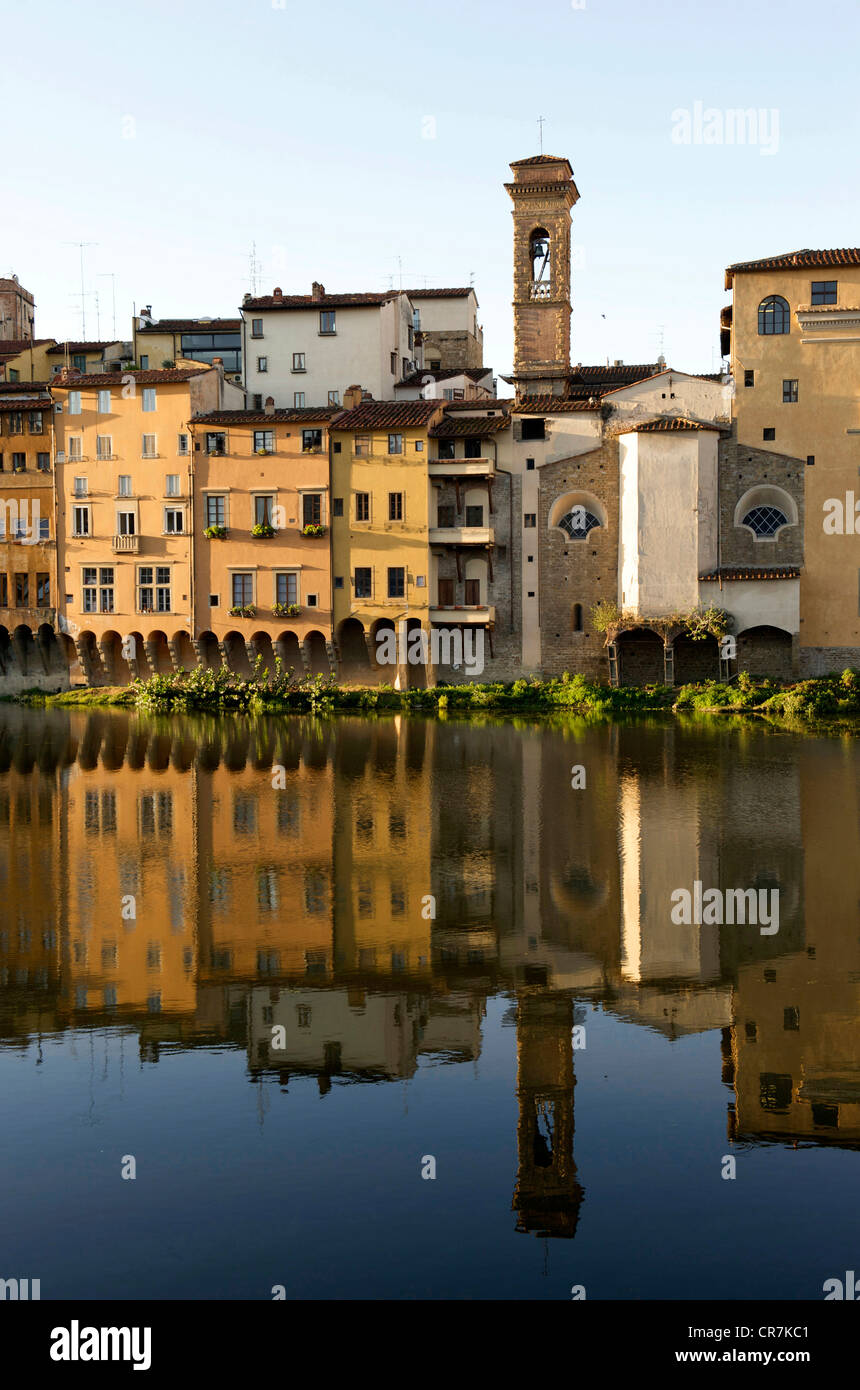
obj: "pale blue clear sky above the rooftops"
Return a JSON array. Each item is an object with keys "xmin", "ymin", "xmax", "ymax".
[{"xmin": 6, "ymin": 0, "xmax": 860, "ymax": 373}]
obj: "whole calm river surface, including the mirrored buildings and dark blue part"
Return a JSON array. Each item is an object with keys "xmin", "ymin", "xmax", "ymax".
[{"xmin": 0, "ymin": 706, "xmax": 860, "ymax": 1300}]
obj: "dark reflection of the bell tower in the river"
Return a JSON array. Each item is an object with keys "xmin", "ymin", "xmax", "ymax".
[{"xmin": 513, "ymin": 990, "xmax": 585, "ymax": 1238}]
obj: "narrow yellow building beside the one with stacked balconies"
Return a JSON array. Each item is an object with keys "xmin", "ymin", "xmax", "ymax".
[{"xmin": 332, "ymin": 388, "xmax": 443, "ymax": 682}]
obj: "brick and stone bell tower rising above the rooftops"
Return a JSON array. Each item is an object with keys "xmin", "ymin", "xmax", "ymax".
[{"xmin": 504, "ymin": 154, "xmax": 579, "ymax": 395}]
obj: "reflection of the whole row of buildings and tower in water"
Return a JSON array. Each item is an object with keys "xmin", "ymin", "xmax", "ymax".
[{"xmin": 0, "ymin": 706, "xmax": 860, "ymax": 1237}]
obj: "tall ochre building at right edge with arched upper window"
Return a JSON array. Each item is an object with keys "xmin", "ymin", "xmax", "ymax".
[{"xmin": 722, "ymin": 247, "xmax": 860, "ymax": 674}]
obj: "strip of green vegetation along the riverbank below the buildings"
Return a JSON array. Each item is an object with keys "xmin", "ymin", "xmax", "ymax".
[{"xmin": 21, "ymin": 664, "xmax": 860, "ymax": 724}]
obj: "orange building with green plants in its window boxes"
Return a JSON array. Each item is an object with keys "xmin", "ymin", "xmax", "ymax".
[{"xmin": 192, "ymin": 406, "xmax": 339, "ymax": 676}]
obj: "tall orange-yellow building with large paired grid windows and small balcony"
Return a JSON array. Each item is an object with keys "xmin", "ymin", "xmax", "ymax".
[{"xmin": 51, "ymin": 367, "xmax": 236, "ymax": 684}]
